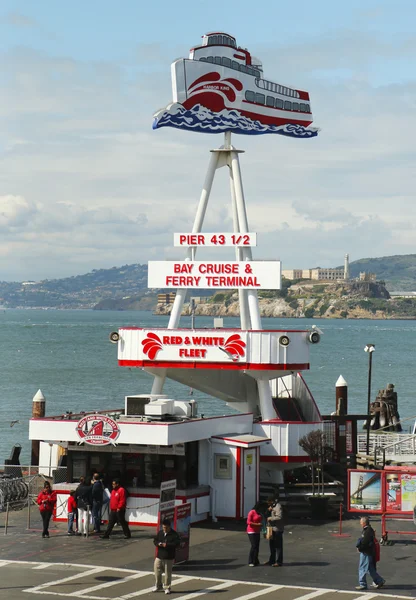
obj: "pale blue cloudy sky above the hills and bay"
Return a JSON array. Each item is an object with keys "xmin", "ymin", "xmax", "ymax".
[{"xmin": 0, "ymin": 0, "xmax": 416, "ymax": 281}]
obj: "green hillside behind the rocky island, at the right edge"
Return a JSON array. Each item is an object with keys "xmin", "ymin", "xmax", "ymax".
[{"xmin": 350, "ymin": 254, "xmax": 416, "ymax": 292}]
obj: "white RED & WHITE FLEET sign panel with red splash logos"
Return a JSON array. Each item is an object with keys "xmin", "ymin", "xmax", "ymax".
[{"xmin": 139, "ymin": 329, "xmax": 247, "ymax": 363}]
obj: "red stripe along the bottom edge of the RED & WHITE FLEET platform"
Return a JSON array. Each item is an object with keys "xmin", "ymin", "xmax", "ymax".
[{"xmin": 118, "ymin": 359, "xmax": 309, "ymax": 371}]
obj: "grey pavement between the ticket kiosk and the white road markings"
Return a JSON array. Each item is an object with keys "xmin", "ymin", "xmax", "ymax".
[{"xmin": 0, "ymin": 507, "xmax": 416, "ymax": 597}]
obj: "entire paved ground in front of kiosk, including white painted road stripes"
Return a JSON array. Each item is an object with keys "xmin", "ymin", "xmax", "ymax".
[{"xmin": 0, "ymin": 509, "xmax": 416, "ymax": 600}]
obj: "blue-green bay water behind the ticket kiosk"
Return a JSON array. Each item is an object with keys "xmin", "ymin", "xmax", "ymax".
[{"xmin": 0, "ymin": 310, "xmax": 416, "ymax": 463}]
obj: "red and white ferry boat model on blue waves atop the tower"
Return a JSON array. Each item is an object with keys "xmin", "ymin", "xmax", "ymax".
[{"xmin": 153, "ymin": 33, "xmax": 317, "ymax": 137}]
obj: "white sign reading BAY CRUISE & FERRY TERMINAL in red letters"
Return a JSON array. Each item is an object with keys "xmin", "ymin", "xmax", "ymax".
[{"xmin": 147, "ymin": 261, "xmax": 282, "ymax": 290}]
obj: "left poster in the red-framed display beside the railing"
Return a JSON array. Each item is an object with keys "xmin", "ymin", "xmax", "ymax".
[{"xmin": 348, "ymin": 470, "xmax": 382, "ymax": 513}]
